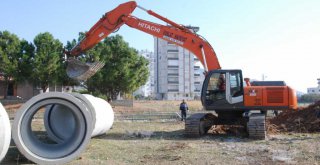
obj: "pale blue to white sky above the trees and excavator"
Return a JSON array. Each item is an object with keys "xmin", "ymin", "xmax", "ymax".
[{"xmin": 0, "ymin": 0, "xmax": 320, "ymax": 92}]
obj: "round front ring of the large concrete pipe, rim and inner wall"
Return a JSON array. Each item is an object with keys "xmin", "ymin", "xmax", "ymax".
[{"xmin": 12, "ymin": 92, "xmax": 93, "ymax": 164}]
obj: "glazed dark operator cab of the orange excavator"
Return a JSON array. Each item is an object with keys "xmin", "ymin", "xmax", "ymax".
[{"xmin": 201, "ymin": 70, "xmax": 244, "ymax": 110}]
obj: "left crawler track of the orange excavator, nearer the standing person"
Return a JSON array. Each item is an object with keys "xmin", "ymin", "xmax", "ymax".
[{"xmin": 185, "ymin": 113, "xmax": 215, "ymax": 138}]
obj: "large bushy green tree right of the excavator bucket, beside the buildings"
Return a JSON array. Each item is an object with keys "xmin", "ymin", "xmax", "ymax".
[{"xmin": 85, "ymin": 35, "xmax": 149, "ymax": 98}]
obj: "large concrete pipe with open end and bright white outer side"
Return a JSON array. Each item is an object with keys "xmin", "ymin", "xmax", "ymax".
[{"xmin": 12, "ymin": 92, "xmax": 114, "ymax": 164}]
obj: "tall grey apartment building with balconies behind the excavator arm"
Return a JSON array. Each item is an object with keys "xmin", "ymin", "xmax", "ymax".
[{"xmin": 154, "ymin": 27, "xmax": 204, "ymax": 100}]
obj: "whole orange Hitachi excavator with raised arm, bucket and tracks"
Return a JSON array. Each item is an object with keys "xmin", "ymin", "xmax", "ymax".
[{"xmin": 67, "ymin": 1, "xmax": 297, "ymax": 139}]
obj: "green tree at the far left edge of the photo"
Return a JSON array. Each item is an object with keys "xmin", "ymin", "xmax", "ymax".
[{"xmin": 0, "ymin": 31, "xmax": 20, "ymax": 98}]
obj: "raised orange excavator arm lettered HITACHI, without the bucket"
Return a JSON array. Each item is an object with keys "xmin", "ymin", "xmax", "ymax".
[{"xmin": 68, "ymin": 1, "xmax": 221, "ymax": 80}]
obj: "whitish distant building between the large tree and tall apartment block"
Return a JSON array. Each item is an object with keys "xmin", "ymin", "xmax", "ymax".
[{"xmin": 134, "ymin": 50, "xmax": 155, "ymax": 97}]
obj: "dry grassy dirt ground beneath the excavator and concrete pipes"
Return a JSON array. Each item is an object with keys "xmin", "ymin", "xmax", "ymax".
[{"xmin": 1, "ymin": 102, "xmax": 320, "ymax": 165}]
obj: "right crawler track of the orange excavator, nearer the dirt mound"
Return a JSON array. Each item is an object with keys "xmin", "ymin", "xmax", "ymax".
[{"xmin": 247, "ymin": 113, "xmax": 267, "ymax": 140}]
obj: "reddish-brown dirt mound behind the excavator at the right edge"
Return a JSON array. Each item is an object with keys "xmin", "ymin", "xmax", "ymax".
[{"xmin": 268, "ymin": 101, "xmax": 320, "ymax": 134}]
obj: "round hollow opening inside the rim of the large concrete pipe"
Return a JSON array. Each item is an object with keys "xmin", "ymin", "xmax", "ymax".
[{"xmin": 20, "ymin": 99, "xmax": 87, "ymax": 159}]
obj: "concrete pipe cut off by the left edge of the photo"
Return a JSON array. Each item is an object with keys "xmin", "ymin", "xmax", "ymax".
[{"xmin": 0, "ymin": 103, "xmax": 11, "ymax": 162}]
